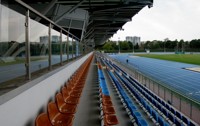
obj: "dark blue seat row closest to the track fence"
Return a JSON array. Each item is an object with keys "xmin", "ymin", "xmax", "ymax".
[{"xmin": 105, "ymin": 58, "xmax": 195, "ymax": 126}]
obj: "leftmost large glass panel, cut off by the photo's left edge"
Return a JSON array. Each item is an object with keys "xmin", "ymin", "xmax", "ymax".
[{"xmin": 0, "ymin": 4, "xmax": 25, "ymax": 87}]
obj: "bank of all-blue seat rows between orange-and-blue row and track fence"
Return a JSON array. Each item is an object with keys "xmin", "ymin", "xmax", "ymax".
[{"xmin": 96, "ymin": 53, "xmax": 197, "ymax": 126}]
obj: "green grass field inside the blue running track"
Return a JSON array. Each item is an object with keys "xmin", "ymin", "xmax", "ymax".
[{"xmin": 135, "ymin": 54, "xmax": 200, "ymax": 65}]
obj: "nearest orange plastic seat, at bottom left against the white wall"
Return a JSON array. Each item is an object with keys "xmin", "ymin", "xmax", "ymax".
[{"xmin": 35, "ymin": 113, "xmax": 52, "ymax": 126}]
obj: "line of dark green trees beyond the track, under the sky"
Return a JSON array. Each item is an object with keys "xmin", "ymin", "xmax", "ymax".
[{"xmin": 97, "ymin": 38, "xmax": 200, "ymax": 52}]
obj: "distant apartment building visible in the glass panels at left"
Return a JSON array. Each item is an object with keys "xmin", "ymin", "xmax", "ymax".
[{"xmin": 40, "ymin": 35, "xmax": 60, "ymax": 45}]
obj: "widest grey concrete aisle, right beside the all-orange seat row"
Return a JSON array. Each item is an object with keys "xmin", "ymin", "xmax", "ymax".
[{"xmin": 73, "ymin": 59, "xmax": 101, "ymax": 126}]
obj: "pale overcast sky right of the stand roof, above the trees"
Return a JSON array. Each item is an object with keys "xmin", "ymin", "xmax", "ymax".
[{"xmin": 111, "ymin": 0, "xmax": 200, "ymax": 41}]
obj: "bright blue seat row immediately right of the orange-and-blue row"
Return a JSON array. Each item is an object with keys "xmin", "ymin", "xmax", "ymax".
[{"xmin": 108, "ymin": 67, "xmax": 148, "ymax": 126}]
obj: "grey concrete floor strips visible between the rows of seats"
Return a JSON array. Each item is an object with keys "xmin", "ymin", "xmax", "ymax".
[{"xmin": 73, "ymin": 56, "xmax": 153, "ymax": 126}]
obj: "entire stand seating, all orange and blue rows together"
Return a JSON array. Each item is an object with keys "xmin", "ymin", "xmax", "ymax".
[{"xmin": 35, "ymin": 53, "xmax": 198, "ymax": 126}]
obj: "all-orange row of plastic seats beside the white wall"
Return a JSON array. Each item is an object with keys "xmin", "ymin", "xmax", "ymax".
[{"xmin": 35, "ymin": 55, "xmax": 93, "ymax": 126}]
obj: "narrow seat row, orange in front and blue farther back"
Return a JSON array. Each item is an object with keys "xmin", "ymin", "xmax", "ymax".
[{"xmin": 97, "ymin": 63, "xmax": 119, "ymax": 126}]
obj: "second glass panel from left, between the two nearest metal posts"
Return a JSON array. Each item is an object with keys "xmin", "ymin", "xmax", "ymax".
[{"xmin": 30, "ymin": 15, "xmax": 49, "ymax": 72}]
